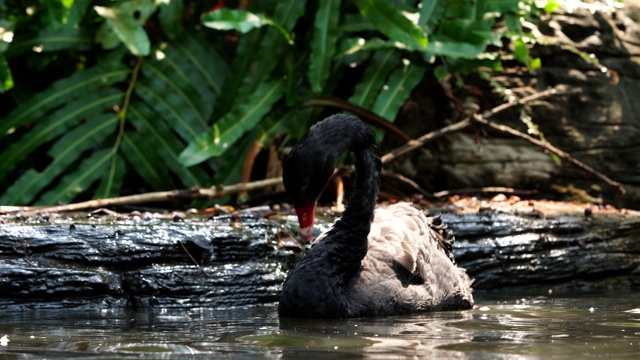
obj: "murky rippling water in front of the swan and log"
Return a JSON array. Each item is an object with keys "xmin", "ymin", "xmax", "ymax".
[{"xmin": 0, "ymin": 289, "xmax": 640, "ymax": 359}]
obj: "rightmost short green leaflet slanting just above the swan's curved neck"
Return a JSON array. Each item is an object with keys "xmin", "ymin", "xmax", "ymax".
[{"xmin": 372, "ymin": 60, "xmax": 425, "ymax": 122}]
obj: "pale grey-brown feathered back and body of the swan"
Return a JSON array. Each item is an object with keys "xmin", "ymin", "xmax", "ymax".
[{"xmin": 347, "ymin": 203, "xmax": 473, "ymax": 316}]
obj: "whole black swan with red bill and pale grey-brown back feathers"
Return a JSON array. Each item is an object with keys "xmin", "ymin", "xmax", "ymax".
[{"xmin": 278, "ymin": 114, "xmax": 473, "ymax": 318}]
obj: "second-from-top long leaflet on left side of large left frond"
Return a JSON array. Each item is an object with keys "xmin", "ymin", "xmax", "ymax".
[{"xmin": 0, "ymin": 88, "xmax": 122, "ymax": 177}]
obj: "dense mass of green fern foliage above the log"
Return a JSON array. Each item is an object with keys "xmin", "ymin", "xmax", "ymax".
[{"xmin": 0, "ymin": 0, "xmax": 556, "ymax": 205}]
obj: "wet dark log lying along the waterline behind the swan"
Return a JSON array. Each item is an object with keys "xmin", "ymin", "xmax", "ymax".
[{"xmin": 0, "ymin": 206, "xmax": 640, "ymax": 310}]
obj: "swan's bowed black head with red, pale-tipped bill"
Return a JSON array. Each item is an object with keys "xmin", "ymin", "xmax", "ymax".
[{"xmin": 282, "ymin": 132, "xmax": 337, "ymax": 242}]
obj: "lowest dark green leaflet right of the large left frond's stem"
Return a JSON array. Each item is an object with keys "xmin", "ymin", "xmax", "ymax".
[{"xmin": 122, "ymin": 131, "xmax": 175, "ymax": 190}]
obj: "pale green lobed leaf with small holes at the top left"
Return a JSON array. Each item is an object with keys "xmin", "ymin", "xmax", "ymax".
[{"xmin": 93, "ymin": 0, "xmax": 156, "ymax": 56}]
